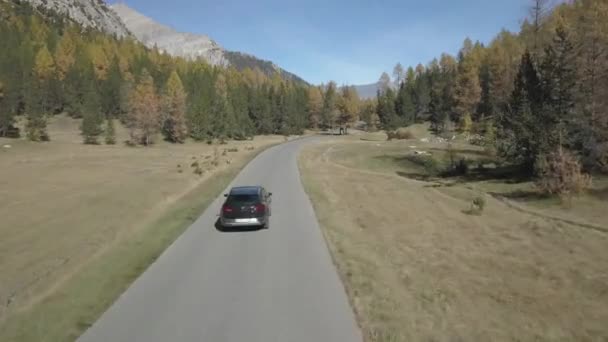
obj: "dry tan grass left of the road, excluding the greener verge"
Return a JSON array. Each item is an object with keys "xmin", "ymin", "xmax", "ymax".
[{"xmin": 0, "ymin": 117, "xmax": 282, "ymax": 340}]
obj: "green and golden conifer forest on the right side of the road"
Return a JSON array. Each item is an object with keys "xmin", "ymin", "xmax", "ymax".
[{"xmin": 376, "ymin": 0, "xmax": 608, "ymax": 179}]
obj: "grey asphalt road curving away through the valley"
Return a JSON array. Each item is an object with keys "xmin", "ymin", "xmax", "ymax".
[{"xmin": 79, "ymin": 138, "xmax": 362, "ymax": 342}]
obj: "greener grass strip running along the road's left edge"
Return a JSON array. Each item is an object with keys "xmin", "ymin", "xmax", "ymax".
[{"xmin": 0, "ymin": 145, "xmax": 272, "ymax": 342}]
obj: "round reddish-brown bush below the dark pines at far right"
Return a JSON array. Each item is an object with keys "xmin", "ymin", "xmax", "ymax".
[{"xmin": 535, "ymin": 148, "xmax": 591, "ymax": 198}]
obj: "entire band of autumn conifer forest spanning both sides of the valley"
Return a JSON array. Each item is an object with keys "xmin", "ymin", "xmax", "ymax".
[{"xmin": 0, "ymin": 0, "xmax": 608, "ymax": 182}]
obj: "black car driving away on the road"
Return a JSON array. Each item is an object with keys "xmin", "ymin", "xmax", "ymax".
[{"xmin": 220, "ymin": 186, "xmax": 272, "ymax": 228}]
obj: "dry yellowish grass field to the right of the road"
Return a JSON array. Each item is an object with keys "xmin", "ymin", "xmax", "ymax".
[{"xmin": 300, "ymin": 126, "xmax": 608, "ymax": 341}]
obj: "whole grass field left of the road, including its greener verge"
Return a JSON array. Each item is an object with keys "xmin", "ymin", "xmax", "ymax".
[{"xmin": 0, "ymin": 116, "xmax": 284, "ymax": 341}]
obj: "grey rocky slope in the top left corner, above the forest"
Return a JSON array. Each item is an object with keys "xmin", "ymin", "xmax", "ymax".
[{"xmin": 20, "ymin": 0, "xmax": 130, "ymax": 37}]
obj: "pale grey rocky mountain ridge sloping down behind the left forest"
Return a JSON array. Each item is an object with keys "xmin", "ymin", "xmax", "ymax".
[{"xmin": 111, "ymin": 3, "xmax": 305, "ymax": 83}]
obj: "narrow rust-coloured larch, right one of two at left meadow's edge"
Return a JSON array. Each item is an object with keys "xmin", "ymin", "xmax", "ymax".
[{"xmin": 163, "ymin": 71, "xmax": 188, "ymax": 143}]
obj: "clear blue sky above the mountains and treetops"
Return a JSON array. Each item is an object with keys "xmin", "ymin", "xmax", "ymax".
[{"xmin": 108, "ymin": 0, "xmax": 530, "ymax": 84}]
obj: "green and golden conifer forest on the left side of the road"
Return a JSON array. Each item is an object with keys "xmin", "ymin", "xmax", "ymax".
[{"xmin": 0, "ymin": 0, "xmax": 320, "ymax": 145}]
